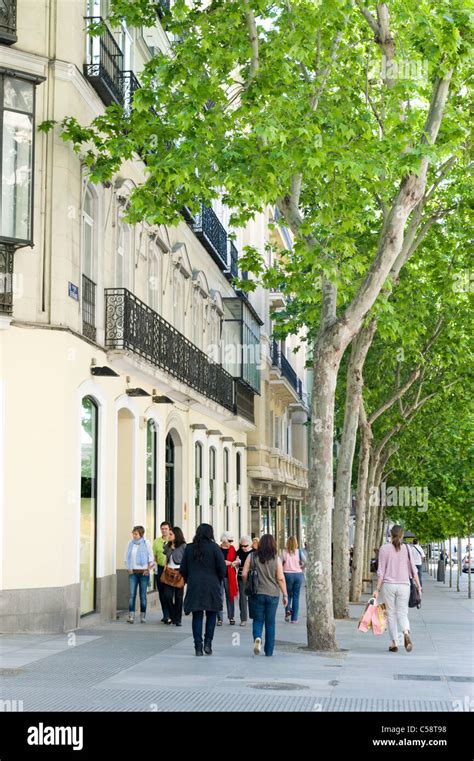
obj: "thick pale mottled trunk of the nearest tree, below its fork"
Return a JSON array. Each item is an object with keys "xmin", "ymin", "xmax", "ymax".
[{"xmin": 306, "ymin": 328, "xmax": 342, "ymax": 650}]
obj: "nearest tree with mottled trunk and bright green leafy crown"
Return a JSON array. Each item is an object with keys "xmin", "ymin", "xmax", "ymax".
[{"xmin": 43, "ymin": 0, "xmax": 469, "ymax": 650}]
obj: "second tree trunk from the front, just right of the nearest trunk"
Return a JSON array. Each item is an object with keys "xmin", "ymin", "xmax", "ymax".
[{"xmin": 333, "ymin": 320, "xmax": 376, "ymax": 618}]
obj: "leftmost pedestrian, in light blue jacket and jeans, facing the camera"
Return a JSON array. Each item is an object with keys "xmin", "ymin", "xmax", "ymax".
[{"xmin": 124, "ymin": 526, "xmax": 155, "ymax": 624}]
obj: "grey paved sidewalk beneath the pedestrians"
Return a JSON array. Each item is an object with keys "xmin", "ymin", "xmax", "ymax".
[{"xmin": 0, "ymin": 574, "xmax": 474, "ymax": 712}]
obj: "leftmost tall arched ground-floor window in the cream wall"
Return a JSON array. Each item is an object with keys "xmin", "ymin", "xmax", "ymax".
[{"xmin": 80, "ymin": 396, "xmax": 98, "ymax": 615}]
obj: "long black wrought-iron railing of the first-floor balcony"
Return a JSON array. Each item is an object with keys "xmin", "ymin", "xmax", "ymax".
[{"xmin": 105, "ymin": 288, "xmax": 235, "ymax": 412}]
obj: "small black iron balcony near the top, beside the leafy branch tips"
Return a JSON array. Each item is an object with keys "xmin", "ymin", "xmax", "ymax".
[{"xmin": 84, "ymin": 16, "xmax": 125, "ymax": 106}]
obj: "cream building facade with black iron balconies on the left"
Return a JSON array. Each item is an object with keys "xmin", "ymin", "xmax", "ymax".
[{"xmin": 0, "ymin": 0, "xmax": 307, "ymax": 631}]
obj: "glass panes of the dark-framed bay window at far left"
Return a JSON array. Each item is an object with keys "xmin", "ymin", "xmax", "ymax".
[{"xmin": 0, "ymin": 75, "xmax": 35, "ymax": 245}]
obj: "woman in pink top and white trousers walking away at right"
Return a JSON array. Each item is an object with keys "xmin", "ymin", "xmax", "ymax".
[{"xmin": 373, "ymin": 525, "xmax": 421, "ymax": 653}]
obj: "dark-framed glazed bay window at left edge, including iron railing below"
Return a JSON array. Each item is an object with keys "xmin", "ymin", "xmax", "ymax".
[{"xmin": 0, "ymin": 67, "xmax": 45, "ymax": 314}]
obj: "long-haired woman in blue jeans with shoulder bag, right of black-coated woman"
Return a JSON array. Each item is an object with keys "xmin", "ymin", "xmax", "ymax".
[{"xmin": 242, "ymin": 534, "xmax": 288, "ymax": 656}]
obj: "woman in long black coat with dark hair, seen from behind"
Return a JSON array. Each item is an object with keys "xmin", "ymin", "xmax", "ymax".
[{"xmin": 180, "ymin": 523, "xmax": 227, "ymax": 655}]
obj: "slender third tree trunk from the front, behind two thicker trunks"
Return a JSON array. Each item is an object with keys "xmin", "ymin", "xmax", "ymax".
[{"xmin": 350, "ymin": 401, "xmax": 372, "ymax": 602}]
